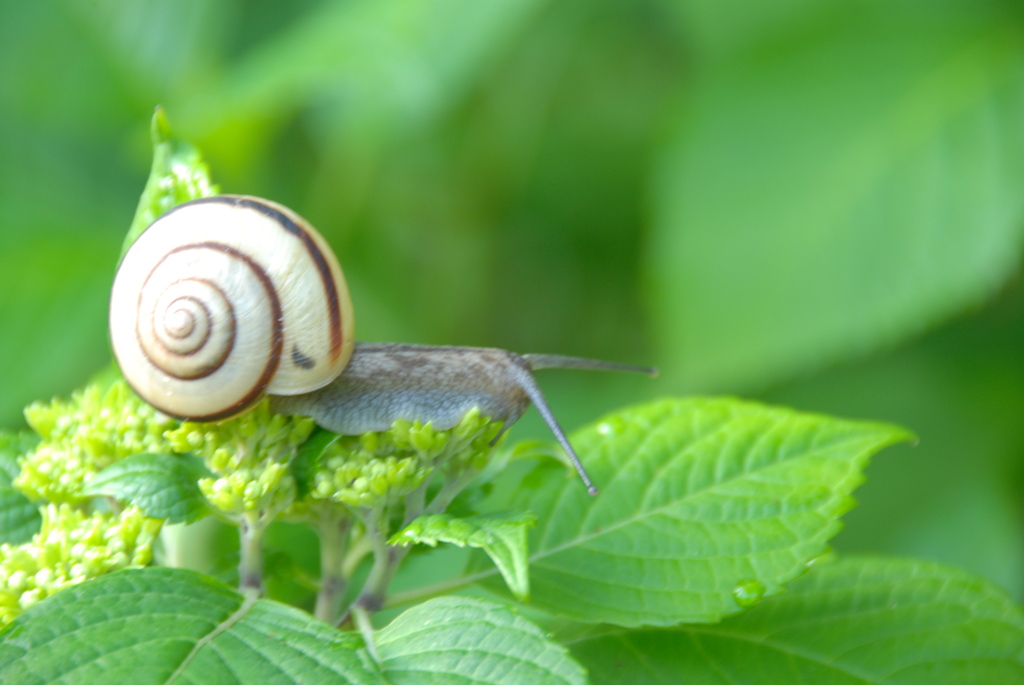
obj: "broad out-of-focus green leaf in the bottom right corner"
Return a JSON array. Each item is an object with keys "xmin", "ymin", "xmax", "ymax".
[{"xmin": 570, "ymin": 559, "xmax": 1024, "ymax": 685}]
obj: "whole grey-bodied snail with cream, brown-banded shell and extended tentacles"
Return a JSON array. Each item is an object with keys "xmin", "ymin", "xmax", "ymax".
[{"xmin": 110, "ymin": 196, "xmax": 656, "ymax": 495}]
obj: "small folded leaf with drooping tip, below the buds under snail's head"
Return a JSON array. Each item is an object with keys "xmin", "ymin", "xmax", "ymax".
[{"xmin": 388, "ymin": 512, "xmax": 537, "ymax": 601}]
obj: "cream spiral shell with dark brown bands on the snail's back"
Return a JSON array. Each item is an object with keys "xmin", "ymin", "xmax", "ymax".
[{"xmin": 110, "ymin": 196, "xmax": 353, "ymax": 421}]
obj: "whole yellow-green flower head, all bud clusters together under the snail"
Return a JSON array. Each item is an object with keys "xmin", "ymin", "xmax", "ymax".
[{"xmin": 0, "ymin": 362, "xmax": 512, "ymax": 628}]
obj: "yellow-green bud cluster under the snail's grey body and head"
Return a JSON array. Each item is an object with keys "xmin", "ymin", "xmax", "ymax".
[{"xmin": 310, "ymin": 409, "xmax": 502, "ymax": 508}]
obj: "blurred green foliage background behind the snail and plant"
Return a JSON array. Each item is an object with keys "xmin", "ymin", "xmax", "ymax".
[{"xmin": 0, "ymin": 0, "xmax": 1024, "ymax": 599}]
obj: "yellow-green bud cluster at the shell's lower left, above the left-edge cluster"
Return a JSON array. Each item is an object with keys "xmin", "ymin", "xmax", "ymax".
[{"xmin": 14, "ymin": 380, "xmax": 174, "ymax": 504}]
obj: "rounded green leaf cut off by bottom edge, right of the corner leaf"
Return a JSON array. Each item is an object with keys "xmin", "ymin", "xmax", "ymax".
[{"xmin": 377, "ymin": 597, "xmax": 587, "ymax": 685}]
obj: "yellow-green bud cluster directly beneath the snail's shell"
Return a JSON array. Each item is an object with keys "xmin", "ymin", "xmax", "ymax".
[{"xmin": 166, "ymin": 399, "xmax": 314, "ymax": 520}]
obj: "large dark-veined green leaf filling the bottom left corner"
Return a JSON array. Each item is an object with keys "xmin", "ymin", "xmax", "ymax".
[{"xmin": 0, "ymin": 568, "xmax": 382, "ymax": 685}]
